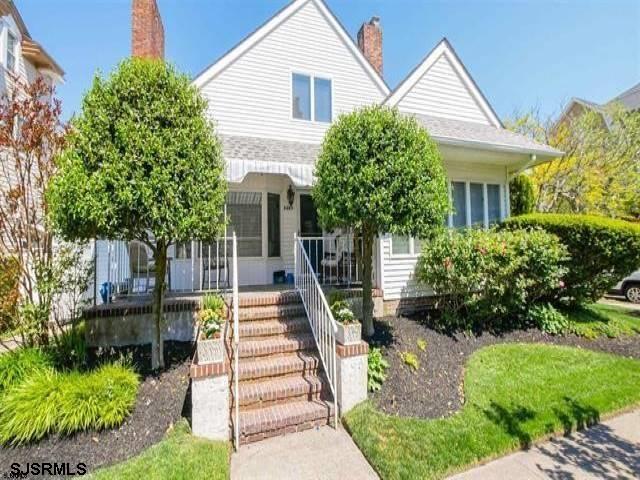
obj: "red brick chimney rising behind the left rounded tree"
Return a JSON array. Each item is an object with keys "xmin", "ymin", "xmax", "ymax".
[{"xmin": 131, "ymin": 0, "xmax": 164, "ymax": 58}]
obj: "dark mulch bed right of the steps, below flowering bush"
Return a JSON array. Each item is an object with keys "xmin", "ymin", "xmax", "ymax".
[{"xmin": 372, "ymin": 317, "xmax": 640, "ymax": 418}]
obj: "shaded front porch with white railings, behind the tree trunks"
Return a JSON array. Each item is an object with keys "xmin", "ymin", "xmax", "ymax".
[{"xmin": 91, "ymin": 173, "xmax": 370, "ymax": 305}]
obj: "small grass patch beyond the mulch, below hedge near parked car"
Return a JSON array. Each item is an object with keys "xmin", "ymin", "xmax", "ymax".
[{"xmin": 567, "ymin": 303, "xmax": 640, "ymax": 338}]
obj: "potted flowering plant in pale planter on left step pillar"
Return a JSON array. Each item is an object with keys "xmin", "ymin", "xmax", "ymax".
[{"xmin": 197, "ymin": 295, "xmax": 225, "ymax": 364}]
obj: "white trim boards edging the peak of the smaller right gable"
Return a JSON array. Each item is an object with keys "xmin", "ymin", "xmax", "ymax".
[{"xmin": 384, "ymin": 38, "xmax": 504, "ymax": 128}]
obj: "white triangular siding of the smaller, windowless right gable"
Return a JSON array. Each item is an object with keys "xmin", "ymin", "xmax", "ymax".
[{"xmin": 398, "ymin": 54, "xmax": 491, "ymax": 125}]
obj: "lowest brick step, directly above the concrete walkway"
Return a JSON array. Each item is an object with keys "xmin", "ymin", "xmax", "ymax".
[{"xmin": 239, "ymin": 400, "xmax": 334, "ymax": 445}]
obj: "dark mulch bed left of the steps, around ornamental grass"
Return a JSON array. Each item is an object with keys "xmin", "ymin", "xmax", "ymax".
[{"xmin": 0, "ymin": 342, "xmax": 192, "ymax": 477}]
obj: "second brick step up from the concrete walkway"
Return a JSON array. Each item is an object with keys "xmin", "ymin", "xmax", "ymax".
[{"xmin": 232, "ymin": 375, "xmax": 331, "ymax": 409}]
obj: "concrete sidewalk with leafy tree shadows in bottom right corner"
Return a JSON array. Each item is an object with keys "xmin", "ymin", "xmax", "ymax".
[{"xmin": 450, "ymin": 410, "xmax": 640, "ymax": 480}]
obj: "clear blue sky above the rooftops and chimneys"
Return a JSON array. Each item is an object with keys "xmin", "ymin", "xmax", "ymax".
[{"xmin": 16, "ymin": 0, "xmax": 640, "ymax": 118}]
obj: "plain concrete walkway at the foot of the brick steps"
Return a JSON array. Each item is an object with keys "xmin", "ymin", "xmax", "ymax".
[{"xmin": 231, "ymin": 427, "xmax": 378, "ymax": 480}]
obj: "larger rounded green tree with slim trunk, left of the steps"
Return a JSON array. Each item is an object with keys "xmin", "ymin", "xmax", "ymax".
[{"xmin": 48, "ymin": 59, "xmax": 226, "ymax": 368}]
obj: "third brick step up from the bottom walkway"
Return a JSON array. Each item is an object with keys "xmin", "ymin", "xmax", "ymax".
[{"xmin": 231, "ymin": 351, "xmax": 322, "ymax": 381}]
